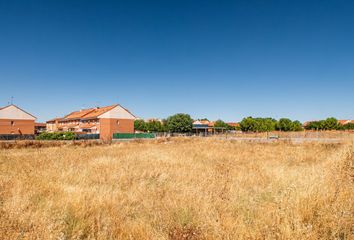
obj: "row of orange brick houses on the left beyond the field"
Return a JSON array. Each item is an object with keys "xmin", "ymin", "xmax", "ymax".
[{"xmin": 0, "ymin": 104, "xmax": 136, "ymax": 140}]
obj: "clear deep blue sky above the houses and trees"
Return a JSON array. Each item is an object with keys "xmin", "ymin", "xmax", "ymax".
[{"xmin": 0, "ymin": 0, "xmax": 354, "ymax": 121}]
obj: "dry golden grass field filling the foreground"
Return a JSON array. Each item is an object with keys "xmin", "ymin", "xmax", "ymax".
[{"xmin": 0, "ymin": 138, "xmax": 354, "ymax": 239}]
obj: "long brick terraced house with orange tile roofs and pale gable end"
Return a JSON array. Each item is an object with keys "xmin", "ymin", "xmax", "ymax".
[{"xmin": 47, "ymin": 104, "xmax": 135, "ymax": 140}]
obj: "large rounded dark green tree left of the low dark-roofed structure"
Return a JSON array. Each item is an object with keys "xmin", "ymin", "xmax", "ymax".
[{"xmin": 166, "ymin": 113, "xmax": 193, "ymax": 133}]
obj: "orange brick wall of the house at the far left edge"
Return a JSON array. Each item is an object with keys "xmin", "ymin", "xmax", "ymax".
[{"xmin": 0, "ymin": 119, "xmax": 34, "ymax": 134}]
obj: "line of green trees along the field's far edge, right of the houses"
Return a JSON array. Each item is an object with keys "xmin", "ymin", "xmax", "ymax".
[{"xmin": 134, "ymin": 113, "xmax": 354, "ymax": 133}]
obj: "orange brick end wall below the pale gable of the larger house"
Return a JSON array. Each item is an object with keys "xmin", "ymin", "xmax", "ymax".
[{"xmin": 100, "ymin": 118, "xmax": 134, "ymax": 140}]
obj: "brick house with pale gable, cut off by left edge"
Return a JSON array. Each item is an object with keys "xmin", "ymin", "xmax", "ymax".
[{"xmin": 0, "ymin": 104, "xmax": 36, "ymax": 135}]
